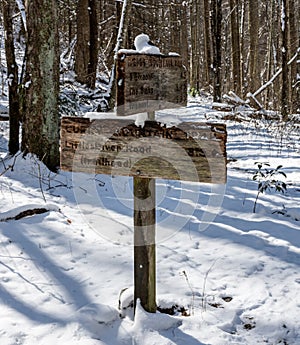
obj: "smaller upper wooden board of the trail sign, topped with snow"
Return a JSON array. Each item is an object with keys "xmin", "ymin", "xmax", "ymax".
[{"xmin": 116, "ymin": 52, "xmax": 187, "ymax": 116}]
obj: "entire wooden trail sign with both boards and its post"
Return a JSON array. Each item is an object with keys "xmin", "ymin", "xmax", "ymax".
[{"xmin": 61, "ymin": 53, "xmax": 227, "ymax": 313}]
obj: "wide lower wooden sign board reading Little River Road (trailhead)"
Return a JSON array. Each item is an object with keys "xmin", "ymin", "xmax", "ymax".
[{"xmin": 60, "ymin": 117, "xmax": 226, "ymax": 184}]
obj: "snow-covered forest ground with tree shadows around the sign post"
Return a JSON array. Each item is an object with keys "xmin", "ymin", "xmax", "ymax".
[{"xmin": 0, "ymin": 102, "xmax": 300, "ymax": 345}]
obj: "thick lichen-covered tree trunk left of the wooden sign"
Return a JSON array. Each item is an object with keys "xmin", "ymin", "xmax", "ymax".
[{"xmin": 22, "ymin": 0, "xmax": 59, "ymax": 171}]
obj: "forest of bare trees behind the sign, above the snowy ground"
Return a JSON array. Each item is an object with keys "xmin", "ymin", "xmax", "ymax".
[{"xmin": 0, "ymin": 0, "xmax": 300, "ymax": 170}]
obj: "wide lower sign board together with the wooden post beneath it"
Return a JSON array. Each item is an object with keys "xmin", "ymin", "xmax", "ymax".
[{"xmin": 61, "ymin": 117, "xmax": 227, "ymax": 312}]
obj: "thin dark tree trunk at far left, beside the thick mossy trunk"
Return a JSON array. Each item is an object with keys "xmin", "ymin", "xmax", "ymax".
[{"xmin": 2, "ymin": 0, "xmax": 20, "ymax": 154}]
